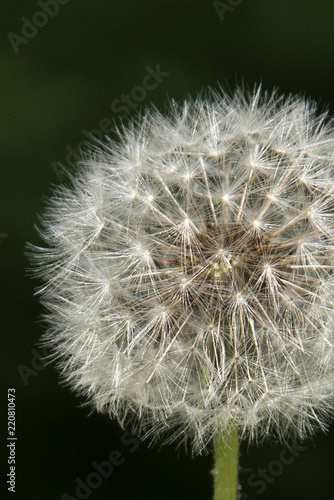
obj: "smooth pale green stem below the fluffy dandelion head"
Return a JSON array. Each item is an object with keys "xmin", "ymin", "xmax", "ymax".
[{"xmin": 213, "ymin": 429, "xmax": 239, "ymax": 500}]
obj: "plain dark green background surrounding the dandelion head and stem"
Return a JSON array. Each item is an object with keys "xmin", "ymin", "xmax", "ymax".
[{"xmin": 0, "ymin": 0, "xmax": 334, "ymax": 500}]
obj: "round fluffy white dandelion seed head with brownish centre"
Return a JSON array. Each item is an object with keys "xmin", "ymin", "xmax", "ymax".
[{"xmin": 34, "ymin": 88, "xmax": 334, "ymax": 453}]
